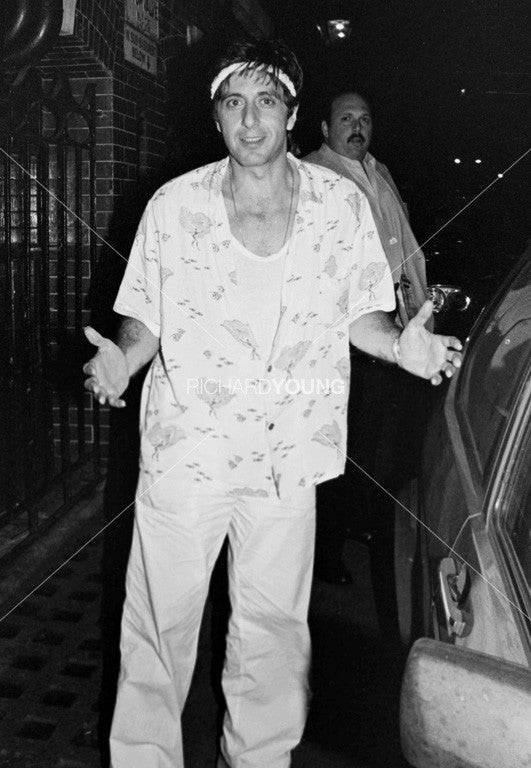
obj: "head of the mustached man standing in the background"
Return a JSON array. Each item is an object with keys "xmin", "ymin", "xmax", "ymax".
[{"xmin": 321, "ymin": 93, "xmax": 372, "ymax": 162}]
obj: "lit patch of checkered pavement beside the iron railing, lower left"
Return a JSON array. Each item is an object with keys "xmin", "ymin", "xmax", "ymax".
[{"xmin": 0, "ymin": 542, "xmax": 101, "ymax": 768}]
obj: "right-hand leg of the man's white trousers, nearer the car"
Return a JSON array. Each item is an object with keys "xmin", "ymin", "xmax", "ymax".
[{"xmin": 222, "ymin": 490, "xmax": 315, "ymax": 768}]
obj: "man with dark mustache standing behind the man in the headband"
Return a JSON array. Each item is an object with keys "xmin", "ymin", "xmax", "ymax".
[{"xmin": 304, "ymin": 88, "xmax": 431, "ymax": 592}]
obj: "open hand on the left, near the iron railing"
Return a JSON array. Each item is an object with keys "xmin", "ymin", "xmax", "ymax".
[{"xmin": 83, "ymin": 325, "xmax": 129, "ymax": 408}]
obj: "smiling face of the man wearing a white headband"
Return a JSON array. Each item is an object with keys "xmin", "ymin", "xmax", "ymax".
[{"xmin": 216, "ymin": 70, "xmax": 295, "ymax": 167}]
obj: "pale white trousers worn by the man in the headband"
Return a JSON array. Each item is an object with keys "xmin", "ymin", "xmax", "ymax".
[{"xmin": 111, "ymin": 489, "xmax": 315, "ymax": 768}]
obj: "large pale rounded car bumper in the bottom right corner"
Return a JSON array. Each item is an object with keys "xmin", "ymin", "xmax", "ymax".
[{"xmin": 400, "ymin": 638, "xmax": 531, "ymax": 768}]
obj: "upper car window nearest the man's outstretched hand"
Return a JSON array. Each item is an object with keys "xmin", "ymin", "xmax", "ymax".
[{"xmin": 455, "ymin": 259, "xmax": 531, "ymax": 489}]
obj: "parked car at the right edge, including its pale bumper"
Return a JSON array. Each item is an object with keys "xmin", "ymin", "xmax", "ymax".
[{"xmin": 395, "ymin": 248, "xmax": 531, "ymax": 768}]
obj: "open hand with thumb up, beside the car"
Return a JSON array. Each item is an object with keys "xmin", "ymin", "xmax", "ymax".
[{"xmin": 399, "ymin": 301, "xmax": 463, "ymax": 385}]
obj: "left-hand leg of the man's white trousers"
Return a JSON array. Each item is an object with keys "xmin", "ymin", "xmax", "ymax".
[{"xmin": 111, "ymin": 499, "xmax": 234, "ymax": 768}]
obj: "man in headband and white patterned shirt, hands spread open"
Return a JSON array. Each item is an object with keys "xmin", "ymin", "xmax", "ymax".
[{"xmin": 84, "ymin": 41, "xmax": 460, "ymax": 768}]
